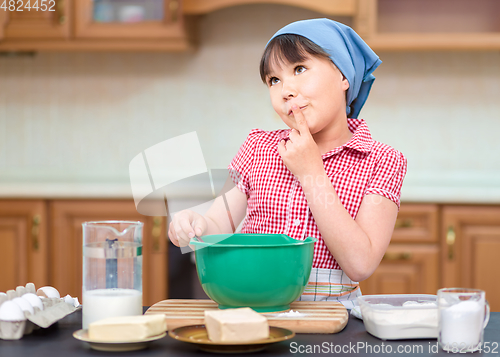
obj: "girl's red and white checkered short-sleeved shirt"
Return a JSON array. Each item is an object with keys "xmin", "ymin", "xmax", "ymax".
[{"xmin": 229, "ymin": 119, "xmax": 406, "ymax": 269}]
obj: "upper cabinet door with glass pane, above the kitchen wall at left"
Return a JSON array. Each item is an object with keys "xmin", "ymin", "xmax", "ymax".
[{"xmin": 75, "ymin": 0, "xmax": 185, "ymax": 40}]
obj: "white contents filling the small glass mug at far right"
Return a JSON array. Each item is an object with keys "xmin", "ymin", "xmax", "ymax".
[{"xmin": 440, "ymin": 300, "xmax": 484, "ymax": 348}]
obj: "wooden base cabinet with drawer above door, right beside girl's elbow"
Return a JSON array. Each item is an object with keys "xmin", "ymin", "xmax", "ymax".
[{"xmin": 360, "ymin": 204, "xmax": 440, "ymax": 295}]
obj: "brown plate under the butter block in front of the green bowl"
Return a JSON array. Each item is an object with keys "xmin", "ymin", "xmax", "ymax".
[{"xmin": 168, "ymin": 325, "xmax": 295, "ymax": 353}]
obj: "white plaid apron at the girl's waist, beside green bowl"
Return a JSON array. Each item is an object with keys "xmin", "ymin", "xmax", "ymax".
[{"xmin": 297, "ymin": 268, "xmax": 361, "ymax": 309}]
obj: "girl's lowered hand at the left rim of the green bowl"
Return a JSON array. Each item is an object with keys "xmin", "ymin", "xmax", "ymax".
[{"xmin": 168, "ymin": 210, "xmax": 207, "ymax": 247}]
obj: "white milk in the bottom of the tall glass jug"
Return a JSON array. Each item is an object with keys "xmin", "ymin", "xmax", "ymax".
[{"xmin": 82, "ymin": 289, "xmax": 142, "ymax": 329}]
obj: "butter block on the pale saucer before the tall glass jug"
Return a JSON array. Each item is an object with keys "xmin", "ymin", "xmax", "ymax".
[{"xmin": 89, "ymin": 314, "xmax": 167, "ymax": 342}]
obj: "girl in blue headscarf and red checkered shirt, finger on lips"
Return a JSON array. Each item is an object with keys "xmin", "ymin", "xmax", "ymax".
[{"xmin": 169, "ymin": 19, "xmax": 406, "ymax": 308}]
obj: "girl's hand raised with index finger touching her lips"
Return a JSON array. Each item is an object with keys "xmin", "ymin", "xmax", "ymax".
[{"xmin": 278, "ymin": 105, "xmax": 324, "ymax": 180}]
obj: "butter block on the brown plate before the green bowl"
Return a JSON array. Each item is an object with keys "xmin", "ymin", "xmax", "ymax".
[{"xmin": 205, "ymin": 307, "xmax": 269, "ymax": 342}]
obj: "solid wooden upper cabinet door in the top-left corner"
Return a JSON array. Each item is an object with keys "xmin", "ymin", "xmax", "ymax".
[{"xmin": 0, "ymin": 0, "xmax": 71, "ymax": 40}]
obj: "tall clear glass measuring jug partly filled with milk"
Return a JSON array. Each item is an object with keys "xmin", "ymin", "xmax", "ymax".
[{"xmin": 82, "ymin": 221, "xmax": 144, "ymax": 329}]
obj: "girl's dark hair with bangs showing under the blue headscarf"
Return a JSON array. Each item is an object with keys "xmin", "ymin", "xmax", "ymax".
[{"xmin": 260, "ymin": 34, "xmax": 330, "ymax": 83}]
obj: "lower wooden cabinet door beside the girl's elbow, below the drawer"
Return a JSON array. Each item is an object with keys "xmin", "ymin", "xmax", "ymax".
[{"xmin": 360, "ymin": 244, "xmax": 439, "ymax": 295}]
